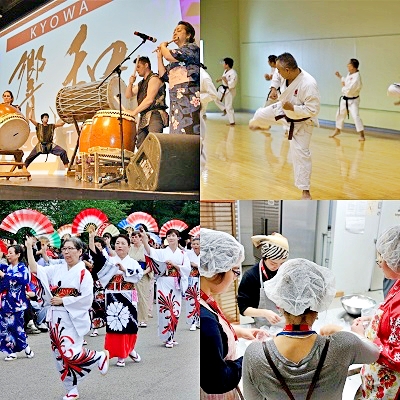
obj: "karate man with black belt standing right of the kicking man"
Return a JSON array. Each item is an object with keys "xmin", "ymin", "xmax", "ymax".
[{"xmin": 329, "ymin": 58, "xmax": 365, "ymax": 141}]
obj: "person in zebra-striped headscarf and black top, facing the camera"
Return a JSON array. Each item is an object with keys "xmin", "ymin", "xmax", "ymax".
[{"xmin": 237, "ymin": 233, "xmax": 289, "ymax": 328}]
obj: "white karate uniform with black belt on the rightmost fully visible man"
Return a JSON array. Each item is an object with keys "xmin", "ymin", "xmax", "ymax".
[{"xmin": 336, "ymin": 72, "xmax": 364, "ymax": 132}]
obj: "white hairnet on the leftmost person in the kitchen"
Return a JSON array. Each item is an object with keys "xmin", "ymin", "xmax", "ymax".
[{"xmin": 199, "ymin": 228, "xmax": 244, "ymax": 278}]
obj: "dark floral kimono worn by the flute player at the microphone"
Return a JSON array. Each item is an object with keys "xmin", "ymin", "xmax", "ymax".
[{"xmin": 162, "ymin": 43, "xmax": 200, "ymax": 135}]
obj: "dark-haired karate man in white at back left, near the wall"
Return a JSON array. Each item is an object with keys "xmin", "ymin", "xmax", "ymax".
[{"xmin": 216, "ymin": 57, "xmax": 238, "ymax": 126}]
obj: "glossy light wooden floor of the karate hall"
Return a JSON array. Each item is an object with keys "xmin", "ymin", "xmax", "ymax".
[{"xmin": 200, "ymin": 113, "xmax": 400, "ymax": 200}]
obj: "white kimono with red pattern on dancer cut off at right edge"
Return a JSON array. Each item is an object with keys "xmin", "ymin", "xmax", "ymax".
[{"xmin": 185, "ymin": 250, "xmax": 200, "ymax": 326}]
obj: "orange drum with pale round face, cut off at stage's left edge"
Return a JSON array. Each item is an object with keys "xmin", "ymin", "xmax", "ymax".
[{"xmin": 0, "ymin": 104, "xmax": 29, "ymax": 150}]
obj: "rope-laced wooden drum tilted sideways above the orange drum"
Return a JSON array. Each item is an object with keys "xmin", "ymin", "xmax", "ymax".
[{"xmin": 56, "ymin": 75, "xmax": 128, "ymax": 124}]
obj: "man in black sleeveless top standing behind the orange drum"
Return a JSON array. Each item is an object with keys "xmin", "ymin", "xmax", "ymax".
[{"xmin": 125, "ymin": 57, "xmax": 168, "ymax": 148}]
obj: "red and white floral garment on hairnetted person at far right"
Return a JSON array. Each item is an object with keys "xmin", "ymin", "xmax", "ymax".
[{"xmin": 355, "ymin": 280, "xmax": 400, "ymax": 400}]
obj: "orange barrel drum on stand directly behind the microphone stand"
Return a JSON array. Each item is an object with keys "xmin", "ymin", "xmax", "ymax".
[{"xmin": 89, "ymin": 110, "xmax": 136, "ymax": 151}]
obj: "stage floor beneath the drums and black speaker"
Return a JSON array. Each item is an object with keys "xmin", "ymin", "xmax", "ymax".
[{"xmin": 0, "ymin": 175, "xmax": 200, "ymax": 200}]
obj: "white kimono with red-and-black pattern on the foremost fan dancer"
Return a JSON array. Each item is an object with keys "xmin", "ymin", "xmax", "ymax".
[{"xmin": 36, "ymin": 260, "xmax": 102, "ymax": 392}]
